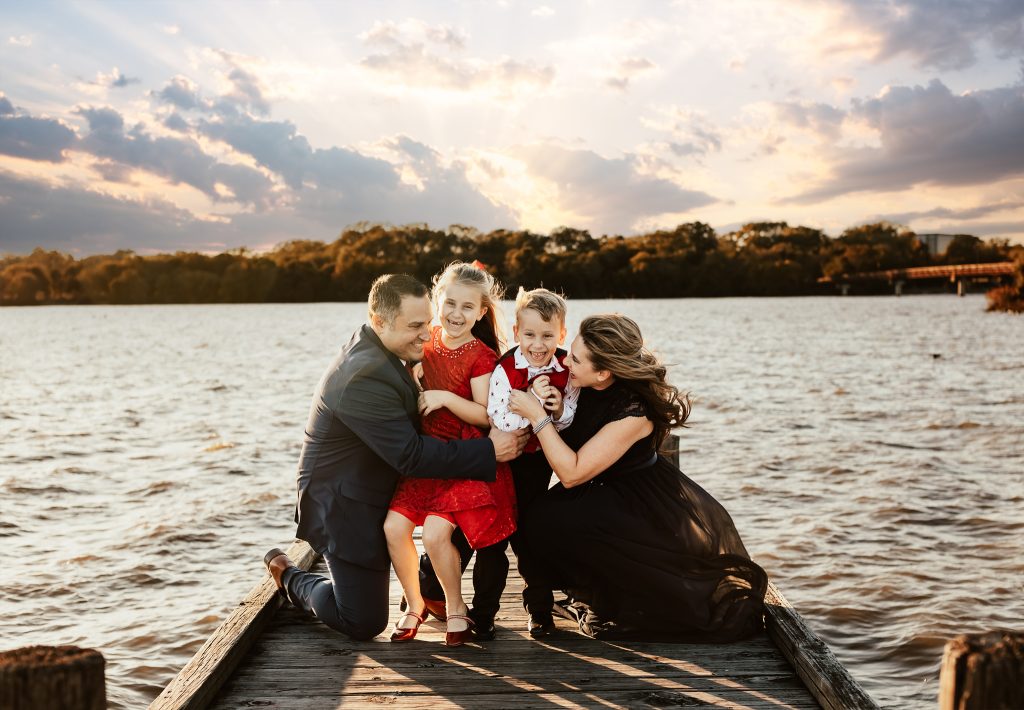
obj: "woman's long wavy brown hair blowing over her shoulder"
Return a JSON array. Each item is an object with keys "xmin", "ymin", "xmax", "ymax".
[{"xmin": 580, "ymin": 314, "xmax": 690, "ymax": 447}]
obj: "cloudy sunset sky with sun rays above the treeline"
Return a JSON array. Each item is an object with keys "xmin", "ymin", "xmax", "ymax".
[{"xmin": 0, "ymin": 0, "xmax": 1024, "ymax": 256}]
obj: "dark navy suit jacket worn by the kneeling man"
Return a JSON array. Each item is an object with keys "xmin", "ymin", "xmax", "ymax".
[{"xmin": 295, "ymin": 325, "xmax": 497, "ymax": 570}]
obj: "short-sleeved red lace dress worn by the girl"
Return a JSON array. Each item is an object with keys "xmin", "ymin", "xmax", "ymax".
[{"xmin": 390, "ymin": 326, "xmax": 516, "ymax": 549}]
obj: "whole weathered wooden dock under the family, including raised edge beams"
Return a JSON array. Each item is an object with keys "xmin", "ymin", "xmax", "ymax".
[{"xmin": 150, "ymin": 542, "xmax": 877, "ymax": 710}]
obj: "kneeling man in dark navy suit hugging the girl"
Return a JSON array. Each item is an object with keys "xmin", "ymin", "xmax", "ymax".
[{"xmin": 264, "ymin": 274, "xmax": 525, "ymax": 639}]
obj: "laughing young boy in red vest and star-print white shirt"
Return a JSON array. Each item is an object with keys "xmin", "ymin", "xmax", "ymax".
[{"xmin": 420, "ymin": 288, "xmax": 579, "ymax": 640}]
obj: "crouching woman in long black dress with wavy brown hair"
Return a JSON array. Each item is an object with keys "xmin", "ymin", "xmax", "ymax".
[{"xmin": 512, "ymin": 315, "xmax": 768, "ymax": 642}]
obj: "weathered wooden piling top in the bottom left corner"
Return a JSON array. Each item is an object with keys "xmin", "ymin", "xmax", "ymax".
[{"xmin": 0, "ymin": 645, "xmax": 106, "ymax": 710}]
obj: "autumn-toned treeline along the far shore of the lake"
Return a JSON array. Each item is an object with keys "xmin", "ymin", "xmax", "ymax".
[{"xmin": 0, "ymin": 222, "xmax": 1024, "ymax": 305}]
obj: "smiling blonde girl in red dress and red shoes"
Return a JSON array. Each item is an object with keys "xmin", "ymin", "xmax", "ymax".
[{"xmin": 384, "ymin": 262, "xmax": 516, "ymax": 645}]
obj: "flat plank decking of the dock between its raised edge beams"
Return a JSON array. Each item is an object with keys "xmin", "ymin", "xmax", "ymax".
[{"xmin": 201, "ymin": 559, "xmax": 839, "ymax": 710}]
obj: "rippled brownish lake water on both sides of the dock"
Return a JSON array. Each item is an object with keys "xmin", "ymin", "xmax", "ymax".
[{"xmin": 0, "ymin": 296, "xmax": 1024, "ymax": 708}]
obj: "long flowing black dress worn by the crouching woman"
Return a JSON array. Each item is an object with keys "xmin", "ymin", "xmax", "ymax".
[{"xmin": 520, "ymin": 380, "xmax": 768, "ymax": 642}]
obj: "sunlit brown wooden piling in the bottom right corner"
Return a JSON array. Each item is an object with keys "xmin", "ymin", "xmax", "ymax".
[{"xmin": 939, "ymin": 631, "xmax": 1024, "ymax": 710}]
